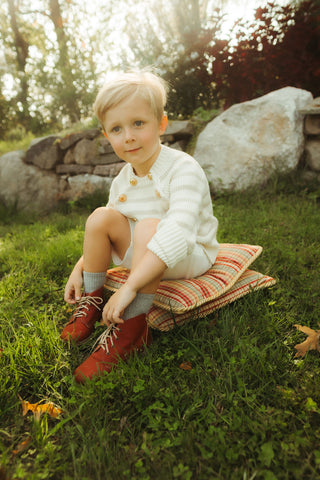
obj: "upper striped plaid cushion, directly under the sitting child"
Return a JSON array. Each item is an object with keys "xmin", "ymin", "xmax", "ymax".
[{"xmin": 105, "ymin": 243, "xmax": 262, "ymax": 314}]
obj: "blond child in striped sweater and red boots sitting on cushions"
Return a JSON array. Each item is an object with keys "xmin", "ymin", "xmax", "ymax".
[{"xmin": 61, "ymin": 72, "xmax": 218, "ymax": 382}]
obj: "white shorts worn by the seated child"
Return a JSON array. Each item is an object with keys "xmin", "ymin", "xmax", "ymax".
[{"xmin": 112, "ymin": 219, "xmax": 212, "ymax": 280}]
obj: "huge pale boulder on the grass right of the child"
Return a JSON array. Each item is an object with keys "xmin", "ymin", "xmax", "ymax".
[{"xmin": 194, "ymin": 87, "xmax": 312, "ymax": 192}]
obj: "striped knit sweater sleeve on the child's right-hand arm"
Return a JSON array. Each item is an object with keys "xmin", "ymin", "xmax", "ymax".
[{"xmin": 148, "ymin": 162, "xmax": 208, "ymax": 268}]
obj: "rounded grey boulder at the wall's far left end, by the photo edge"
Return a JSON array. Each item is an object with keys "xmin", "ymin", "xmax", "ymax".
[{"xmin": 0, "ymin": 150, "xmax": 67, "ymax": 213}]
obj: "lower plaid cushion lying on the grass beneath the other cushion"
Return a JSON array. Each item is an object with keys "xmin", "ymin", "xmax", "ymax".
[{"xmin": 147, "ymin": 270, "xmax": 276, "ymax": 331}]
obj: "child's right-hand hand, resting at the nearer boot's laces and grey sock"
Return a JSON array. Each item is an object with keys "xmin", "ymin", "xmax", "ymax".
[{"xmin": 101, "ymin": 284, "xmax": 137, "ymax": 326}]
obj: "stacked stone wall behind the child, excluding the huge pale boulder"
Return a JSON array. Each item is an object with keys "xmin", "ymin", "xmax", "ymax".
[{"xmin": 0, "ymin": 121, "xmax": 194, "ymax": 213}]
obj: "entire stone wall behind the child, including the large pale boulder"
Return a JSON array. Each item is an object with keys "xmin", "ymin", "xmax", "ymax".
[{"xmin": 0, "ymin": 87, "xmax": 320, "ymax": 213}]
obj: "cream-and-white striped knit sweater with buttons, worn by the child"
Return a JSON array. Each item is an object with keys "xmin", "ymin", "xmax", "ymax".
[{"xmin": 107, "ymin": 145, "xmax": 219, "ymax": 268}]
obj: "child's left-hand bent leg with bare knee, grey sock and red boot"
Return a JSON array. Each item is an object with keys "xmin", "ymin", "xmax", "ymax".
[{"xmin": 61, "ymin": 207, "xmax": 131, "ymax": 342}]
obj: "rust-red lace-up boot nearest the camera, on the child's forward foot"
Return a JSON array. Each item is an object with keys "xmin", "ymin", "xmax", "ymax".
[{"xmin": 74, "ymin": 313, "xmax": 152, "ymax": 383}]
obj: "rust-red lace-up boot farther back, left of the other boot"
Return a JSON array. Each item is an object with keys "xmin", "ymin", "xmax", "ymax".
[{"xmin": 60, "ymin": 287, "xmax": 104, "ymax": 343}]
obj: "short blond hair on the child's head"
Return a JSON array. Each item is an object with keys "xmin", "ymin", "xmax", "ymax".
[{"xmin": 93, "ymin": 71, "xmax": 168, "ymax": 124}]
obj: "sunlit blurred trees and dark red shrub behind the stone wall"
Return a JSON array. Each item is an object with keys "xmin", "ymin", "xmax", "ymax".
[{"xmin": 0, "ymin": 0, "xmax": 320, "ymax": 138}]
